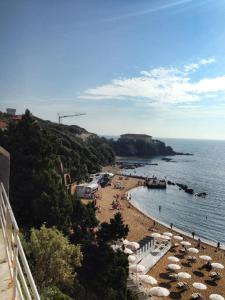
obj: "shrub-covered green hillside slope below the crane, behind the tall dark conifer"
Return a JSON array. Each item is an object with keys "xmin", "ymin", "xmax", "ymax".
[{"xmin": 36, "ymin": 118, "xmax": 115, "ymax": 181}]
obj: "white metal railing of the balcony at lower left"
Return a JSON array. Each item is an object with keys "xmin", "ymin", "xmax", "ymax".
[{"xmin": 0, "ymin": 183, "xmax": 40, "ymax": 300}]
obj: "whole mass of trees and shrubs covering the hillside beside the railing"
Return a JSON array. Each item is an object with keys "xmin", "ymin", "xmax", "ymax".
[{"xmin": 0, "ymin": 111, "xmax": 135, "ymax": 300}]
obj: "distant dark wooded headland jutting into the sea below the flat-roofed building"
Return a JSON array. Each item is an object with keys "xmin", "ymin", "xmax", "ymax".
[{"xmin": 109, "ymin": 138, "xmax": 177, "ymax": 157}]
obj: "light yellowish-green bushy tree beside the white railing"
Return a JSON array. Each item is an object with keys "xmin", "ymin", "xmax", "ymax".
[{"xmin": 26, "ymin": 225, "xmax": 82, "ymax": 291}]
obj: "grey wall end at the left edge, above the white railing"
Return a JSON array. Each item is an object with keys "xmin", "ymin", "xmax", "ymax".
[{"xmin": 0, "ymin": 146, "xmax": 10, "ymax": 194}]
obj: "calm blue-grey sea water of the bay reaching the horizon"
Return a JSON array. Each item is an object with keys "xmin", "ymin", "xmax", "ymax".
[{"xmin": 120, "ymin": 139, "xmax": 225, "ymax": 244}]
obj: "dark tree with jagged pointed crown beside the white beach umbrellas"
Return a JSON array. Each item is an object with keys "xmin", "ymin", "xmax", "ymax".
[{"xmin": 74, "ymin": 213, "xmax": 129, "ymax": 300}]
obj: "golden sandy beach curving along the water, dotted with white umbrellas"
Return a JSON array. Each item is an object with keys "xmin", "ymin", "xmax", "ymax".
[{"xmin": 94, "ymin": 175, "xmax": 225, "ymax": 299}]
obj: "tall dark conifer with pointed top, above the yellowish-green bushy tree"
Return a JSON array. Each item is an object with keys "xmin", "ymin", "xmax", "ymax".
[{"xmin": 0, "ymin": 110, "xmax": 72, "ymax": 228}]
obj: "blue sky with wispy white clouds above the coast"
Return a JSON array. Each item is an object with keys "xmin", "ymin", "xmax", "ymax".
[{"xmin": 0, "ymin": 0, "xmax": 225, "ymax": 139}]
